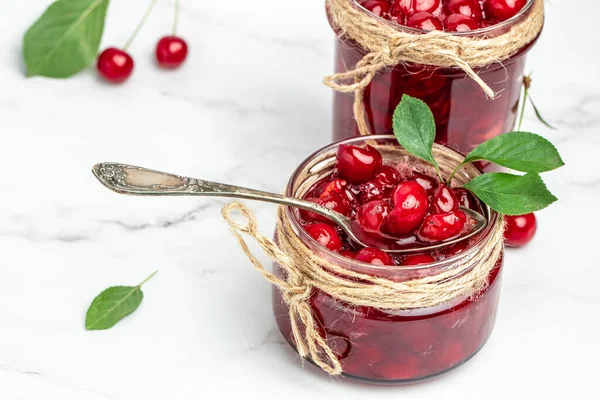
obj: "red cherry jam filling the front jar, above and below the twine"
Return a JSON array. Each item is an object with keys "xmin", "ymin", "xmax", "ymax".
[{"xmin": 273, "ymin": 136, "xmax": 503, "ymax": 384}]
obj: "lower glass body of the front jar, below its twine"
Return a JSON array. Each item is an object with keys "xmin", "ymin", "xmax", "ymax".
[{"xmin": 273, "ymin": 260, "xmax": 502, "ymax": 384}]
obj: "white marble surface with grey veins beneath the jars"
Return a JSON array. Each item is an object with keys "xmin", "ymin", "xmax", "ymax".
[{"xmin": 0, "ymin": 0, "xmax": 600, "ymax": 400}]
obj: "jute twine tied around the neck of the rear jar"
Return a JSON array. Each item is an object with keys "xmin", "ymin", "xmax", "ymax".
[{"xmin": 323, "ymin": 0, "xmax": 544, "ymax": 135}]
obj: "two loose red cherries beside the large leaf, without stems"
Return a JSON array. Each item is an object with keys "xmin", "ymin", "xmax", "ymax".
[{"xmin": 97, "ymin": 36, "xmax": 188, "ymax": 83}]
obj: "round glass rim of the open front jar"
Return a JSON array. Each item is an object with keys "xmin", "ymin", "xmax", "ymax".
[{"xmin": 284, "ymin": 135, "xmax": 499, "ymax": 273}]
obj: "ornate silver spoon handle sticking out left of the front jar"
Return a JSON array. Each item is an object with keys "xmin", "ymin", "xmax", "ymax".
[{"xmin": 92, "ymin": 163, "xmax": 342, "ymax": 222}]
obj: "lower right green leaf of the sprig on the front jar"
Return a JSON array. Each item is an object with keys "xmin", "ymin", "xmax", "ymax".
[{"xmin": 465, "ymin": 172, "xmax": 557, "ymax": 215}]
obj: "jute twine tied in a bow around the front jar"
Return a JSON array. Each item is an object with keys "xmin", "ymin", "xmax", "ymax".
[{"xmin": 221, "ymin": 202, "xmax": 504, "ymax": 375}]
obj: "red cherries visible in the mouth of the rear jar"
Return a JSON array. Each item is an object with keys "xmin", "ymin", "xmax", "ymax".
[{"xmin": 358, "ymin": 0, "xmax": 528, "ymax": 32}]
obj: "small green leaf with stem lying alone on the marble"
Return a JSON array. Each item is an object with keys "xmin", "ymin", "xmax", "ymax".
[{"xmin": 85, "ymin": 271, "xmax": 158, "ymax": 331}]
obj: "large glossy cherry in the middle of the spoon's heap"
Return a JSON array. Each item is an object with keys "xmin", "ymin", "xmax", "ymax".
[{"xmin": 381, "ymin": 181, "xmax": 429, "ymax": 237}]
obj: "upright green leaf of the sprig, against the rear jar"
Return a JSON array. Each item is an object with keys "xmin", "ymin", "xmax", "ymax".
[{"xmin": 393, "ymin": 95, "xmax": 439, "ymax": 173}]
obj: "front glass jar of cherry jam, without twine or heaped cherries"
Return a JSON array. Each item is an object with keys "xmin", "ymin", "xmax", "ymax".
[{"xmin": 273, "ymin": 135, "xmax": 503, "ymax": 384}]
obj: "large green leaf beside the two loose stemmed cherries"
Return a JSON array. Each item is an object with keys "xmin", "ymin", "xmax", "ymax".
[{"xmin": 23, "ymin": 0, "xmax": 109, "ymax": 78}]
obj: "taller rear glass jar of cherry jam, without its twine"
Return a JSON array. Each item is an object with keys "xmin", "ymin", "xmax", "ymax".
[{"xmin": 330, "ymin": 0, "xmax": 542, "ymax": 154}]
